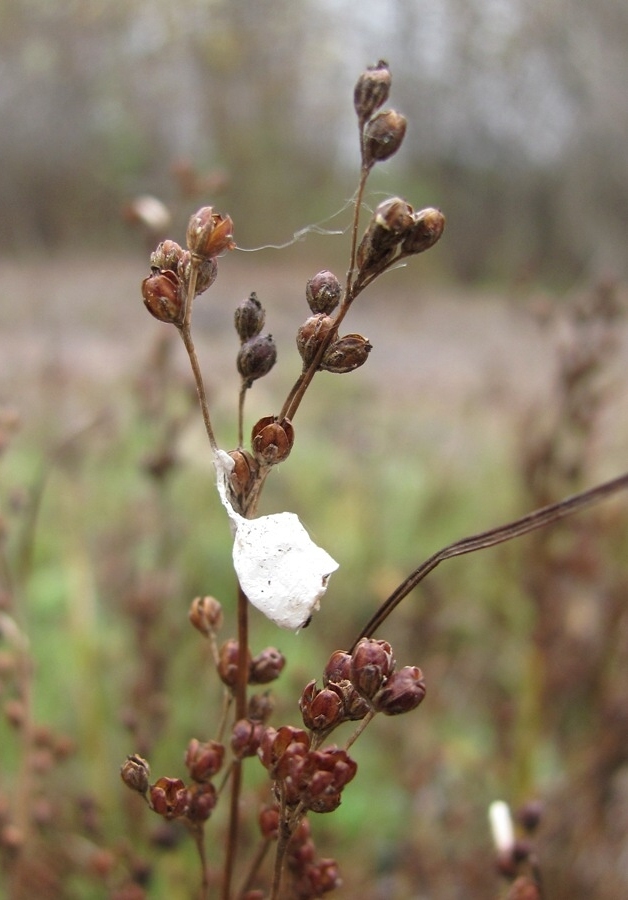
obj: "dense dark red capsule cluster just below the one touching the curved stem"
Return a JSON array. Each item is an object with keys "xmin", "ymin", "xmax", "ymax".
[{"xmin": 258, "ymin": 725, "xmax": 357, "ymax": 813}]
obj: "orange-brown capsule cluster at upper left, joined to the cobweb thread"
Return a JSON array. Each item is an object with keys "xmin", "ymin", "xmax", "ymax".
[{"xmin": 142, "ymin": 206, "xmax": 235, "ymax": 326}]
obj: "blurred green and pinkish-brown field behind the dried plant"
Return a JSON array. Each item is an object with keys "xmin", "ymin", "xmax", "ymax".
[{"xmin": 0, "ymin": 250, "xmax": 628, "ymax": 900}]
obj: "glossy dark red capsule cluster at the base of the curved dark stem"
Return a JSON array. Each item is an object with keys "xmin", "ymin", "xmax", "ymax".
[{"xmin": 299, "ymin": 638, "xmax": 425, "ymax": 735}]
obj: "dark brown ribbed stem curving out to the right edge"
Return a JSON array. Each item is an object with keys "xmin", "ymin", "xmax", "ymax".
[{"xmin": 350, "ymin": 473, "xmax": 628, "ymax": 652}]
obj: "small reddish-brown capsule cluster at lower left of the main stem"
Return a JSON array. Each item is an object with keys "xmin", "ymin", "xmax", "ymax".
[{"xmin": 120, "ymin": 739, "xmax": 225, "ymax": 824}]
